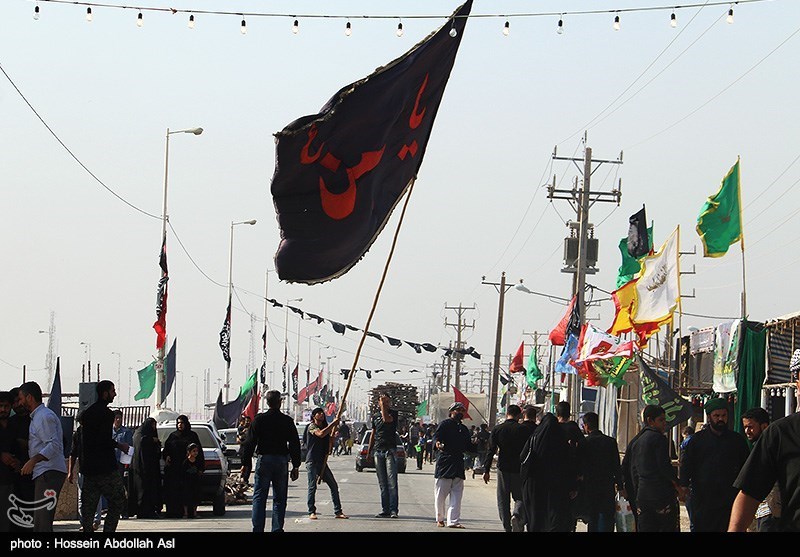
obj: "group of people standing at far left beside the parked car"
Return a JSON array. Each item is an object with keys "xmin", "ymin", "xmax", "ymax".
[{"xmin": 0, "ymin": 380, "xmax": 217, "ymax": 533}]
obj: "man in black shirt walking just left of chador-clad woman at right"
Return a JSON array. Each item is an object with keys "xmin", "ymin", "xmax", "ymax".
[{"xmin": 483, "ymin": 404, "xmax": 533, "ymax": 532}]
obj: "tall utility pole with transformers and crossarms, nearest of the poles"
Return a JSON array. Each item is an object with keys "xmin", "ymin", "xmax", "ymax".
[{"xmin": 547, "ymin": 138, "xmax": 622, "ymax": 417}]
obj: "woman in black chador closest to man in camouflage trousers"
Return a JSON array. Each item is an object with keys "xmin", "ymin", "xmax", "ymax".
[{"xmin": 130, "ymin": 418, "xmax": 162, "ymax": 518}]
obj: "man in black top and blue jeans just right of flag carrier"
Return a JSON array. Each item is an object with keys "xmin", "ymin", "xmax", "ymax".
[{"xmin": 369, "ymin": 393, "xmax": 399, "ymax": 518}]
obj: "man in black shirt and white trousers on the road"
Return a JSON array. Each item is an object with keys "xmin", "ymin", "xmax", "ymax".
[{"xmin": 433, "ymin": 402, "xmax": 473, "ymax": 528}]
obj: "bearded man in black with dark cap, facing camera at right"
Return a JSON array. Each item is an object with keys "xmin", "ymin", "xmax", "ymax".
[{"xmin": 680, "ymin": 398, "xmax": 749, "ymax": 532}]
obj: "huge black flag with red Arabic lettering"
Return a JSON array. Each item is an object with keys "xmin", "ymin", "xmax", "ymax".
[{"xmin": 271, "ymin": 0, "xmax": 472, "ymax": 284}]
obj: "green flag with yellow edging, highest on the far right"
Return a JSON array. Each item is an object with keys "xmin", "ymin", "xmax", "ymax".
[{"xmin": 697, "ymin": 159, "xmax": 742, "ymax": 257}]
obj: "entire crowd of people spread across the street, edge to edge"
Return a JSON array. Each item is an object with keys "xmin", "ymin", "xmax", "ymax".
[{"xmin": 0, "ymin": 364, "xmax": 800, "ymax": 533}]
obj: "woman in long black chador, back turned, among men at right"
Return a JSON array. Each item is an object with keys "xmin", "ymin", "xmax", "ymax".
[{"xmin": 520, "ymin": 412, "xmax": 575, "ymax": 532}]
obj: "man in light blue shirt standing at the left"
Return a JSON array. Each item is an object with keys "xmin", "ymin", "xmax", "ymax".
[{"xmin": 17, "ymin": 381, "xmax": 66, "ymax": 532}]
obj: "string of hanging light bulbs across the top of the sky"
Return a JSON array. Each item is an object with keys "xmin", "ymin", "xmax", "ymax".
[{"xmin": 28, "ymin": 0, "xmax": 760, "ymax": 37}]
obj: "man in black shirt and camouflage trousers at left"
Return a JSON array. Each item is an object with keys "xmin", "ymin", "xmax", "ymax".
[{"xmin": 79, "ymin": 380, "xmax": 130, "ymax": 533}]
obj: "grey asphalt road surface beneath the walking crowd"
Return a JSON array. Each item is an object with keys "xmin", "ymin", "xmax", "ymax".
[{"xmin": 54, "ymin": 456, "xmax": 688, "ymax": 535}]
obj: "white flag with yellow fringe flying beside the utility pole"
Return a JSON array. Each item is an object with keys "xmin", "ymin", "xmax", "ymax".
[{"xmin": 631, "ymin": 227, "xmax": 681, "ymax": 323}]
